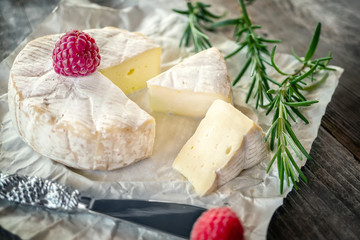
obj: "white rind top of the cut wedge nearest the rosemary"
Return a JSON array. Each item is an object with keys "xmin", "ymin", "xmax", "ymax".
[{"xmin": 147, "ymin": 47, "xmax": 231, "ymax": 99}]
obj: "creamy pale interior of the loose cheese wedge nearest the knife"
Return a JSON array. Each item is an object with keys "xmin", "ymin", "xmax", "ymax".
[{"xmin": 173, "ymin": 100, "xmax": 261, "ymax": 195}]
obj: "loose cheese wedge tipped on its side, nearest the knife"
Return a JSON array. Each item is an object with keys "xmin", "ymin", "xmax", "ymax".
[{"xmin": 173, "ymin": 100, "xmax": 267, "ymax": 196}]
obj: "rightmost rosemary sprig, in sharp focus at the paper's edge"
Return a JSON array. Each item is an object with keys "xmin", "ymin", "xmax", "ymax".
[{"xmin": 265, "ymin": 23, "xmax": 333, "ymax": 193}]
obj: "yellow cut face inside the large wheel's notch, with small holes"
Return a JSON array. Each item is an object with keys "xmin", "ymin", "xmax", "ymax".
[{"xmin": 100, "ymin": 47, "xmax": 161, "ymax": 94}]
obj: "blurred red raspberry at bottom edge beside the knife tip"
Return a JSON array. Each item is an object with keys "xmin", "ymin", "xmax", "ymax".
[{"xmin": 191, "ymin": 207, "xmax": 244, "ymax": 240}]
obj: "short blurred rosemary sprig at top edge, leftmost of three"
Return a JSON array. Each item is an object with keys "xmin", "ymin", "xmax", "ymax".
[{"xmin": 173, "ymin": 1, "xmax": 224, "ymax": 52}]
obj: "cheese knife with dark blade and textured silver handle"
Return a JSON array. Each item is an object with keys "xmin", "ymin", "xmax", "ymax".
[{"xmin": 0, "ymin": 173, "xmax": 206, "ymax": 239}]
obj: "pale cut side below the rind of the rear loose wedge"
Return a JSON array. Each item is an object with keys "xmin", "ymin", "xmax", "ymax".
[{"xmin": 148, "ymin": 85, "xmax": 231, "ymax": 117}]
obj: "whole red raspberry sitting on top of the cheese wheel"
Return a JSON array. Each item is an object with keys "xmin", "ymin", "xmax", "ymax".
[{"xmin": 52, "ymin": 30, "xmax": 101, "ymax": 77}]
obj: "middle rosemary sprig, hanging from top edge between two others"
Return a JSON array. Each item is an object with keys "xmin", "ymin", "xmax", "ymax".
[{"xmin": 212, "ymin": 0, "xmax": 281, "ymax": 108}]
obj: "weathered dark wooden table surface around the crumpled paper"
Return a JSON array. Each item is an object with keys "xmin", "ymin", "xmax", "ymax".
[{"xmin": 0, "ymin": 0, "xmax": 360, "ymax": 239}]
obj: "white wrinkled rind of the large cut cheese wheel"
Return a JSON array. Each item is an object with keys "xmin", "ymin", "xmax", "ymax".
[{"xmin": 8, "ymin": 28, "xmax": 158, "ymax": 170}]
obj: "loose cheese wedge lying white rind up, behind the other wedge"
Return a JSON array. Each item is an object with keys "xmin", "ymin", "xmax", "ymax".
[{"xmin": 147, "ymin": 48, "xmax": 231, "ymax": 117}]
